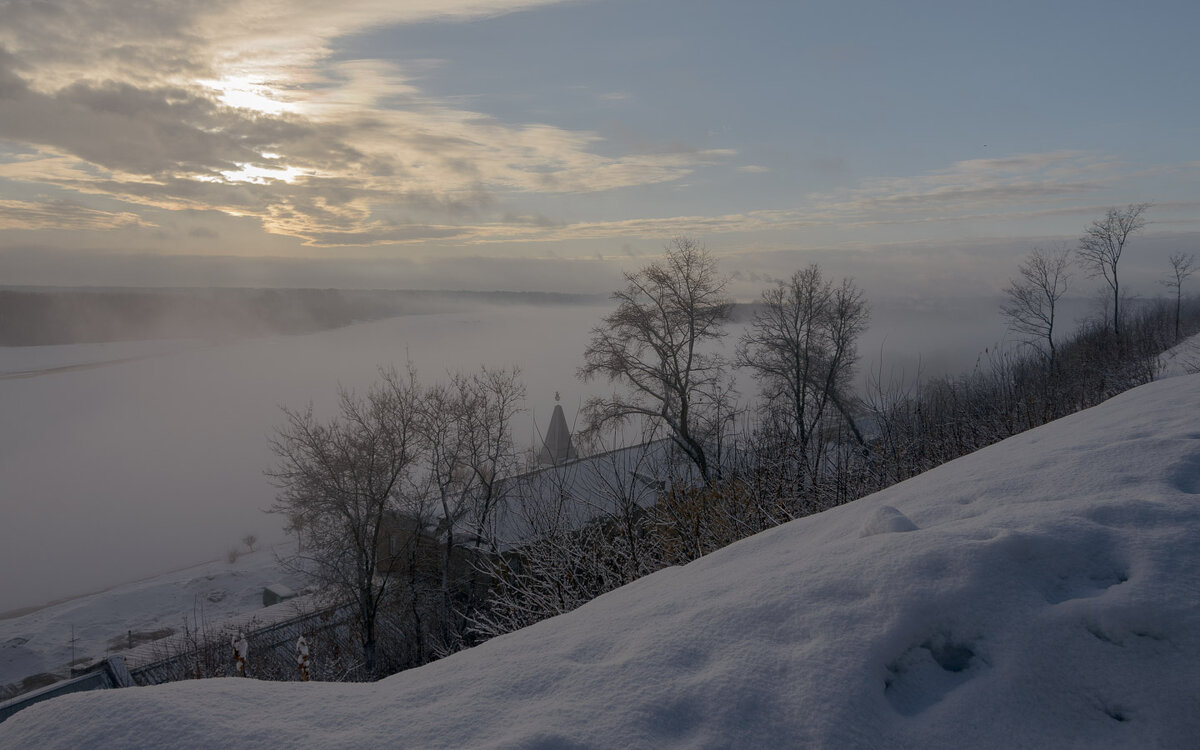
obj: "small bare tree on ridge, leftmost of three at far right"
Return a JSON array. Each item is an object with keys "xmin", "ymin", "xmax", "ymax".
[{"xmin": 1000, "ymin": 245, "xmax": 1070, "ymax": 368}]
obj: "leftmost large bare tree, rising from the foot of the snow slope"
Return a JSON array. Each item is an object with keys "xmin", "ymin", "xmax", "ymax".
[{"xmin": 266, "ymin": 374, "xmax": 420, "ymax": 673}]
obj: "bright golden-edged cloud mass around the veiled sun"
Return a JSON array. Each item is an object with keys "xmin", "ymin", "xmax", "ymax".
[{"xmin": 0, "ymin": 0, "xmax": 731, "ymax": 245}]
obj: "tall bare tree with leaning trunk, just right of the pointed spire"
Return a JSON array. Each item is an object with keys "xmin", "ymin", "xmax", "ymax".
[{"xmin": 578, "ymin": 238, "xmax": 732, "ymax": 482}]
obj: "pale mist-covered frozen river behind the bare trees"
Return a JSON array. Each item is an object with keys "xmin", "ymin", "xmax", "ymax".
[{"xmin": 0, "ymin": 295, "xmax": 1022, "ymax": 612}]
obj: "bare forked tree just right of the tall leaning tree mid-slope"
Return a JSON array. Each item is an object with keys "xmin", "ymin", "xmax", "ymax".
[{"xmin": 738, "ymin": 264, "xmax": 870, "ymax": 478}]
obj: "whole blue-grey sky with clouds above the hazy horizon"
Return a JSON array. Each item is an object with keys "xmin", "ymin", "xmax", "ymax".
[{"xmin": 0, "ymin": 0, "xmax": 1200, "ymax": 296}]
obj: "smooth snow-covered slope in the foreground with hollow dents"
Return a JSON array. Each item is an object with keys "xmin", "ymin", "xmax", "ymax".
[{"xmin": 0, "ymin": 376, "xmax": 1200, "ymax": 749}]
